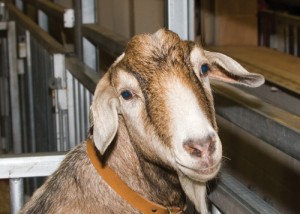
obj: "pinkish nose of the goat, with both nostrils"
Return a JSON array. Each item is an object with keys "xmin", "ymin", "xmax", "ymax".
[{"xmin": 183, "ymin": 136, "xmax": 216, "ymax": 158}]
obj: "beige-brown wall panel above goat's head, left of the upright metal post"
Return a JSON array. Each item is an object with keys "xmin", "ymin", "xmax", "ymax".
[{"xmin": 97, "ymin": 0, "xmax": 164, "ymax": 38}]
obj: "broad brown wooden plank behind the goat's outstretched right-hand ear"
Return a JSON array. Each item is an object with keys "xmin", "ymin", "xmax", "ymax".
[{"xmin": 208, "ymin": 46, "xmax": 300, "ymax": 94}]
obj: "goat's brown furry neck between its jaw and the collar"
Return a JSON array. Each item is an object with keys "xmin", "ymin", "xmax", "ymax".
[{"xmin": 106, "ymin": 116, "xmax": 185, "ymax": 208}]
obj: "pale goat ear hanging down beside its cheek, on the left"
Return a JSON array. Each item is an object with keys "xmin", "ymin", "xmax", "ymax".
[{"xmin": 91, "ymin": 73, "xmax": 120, "ymax": 155}]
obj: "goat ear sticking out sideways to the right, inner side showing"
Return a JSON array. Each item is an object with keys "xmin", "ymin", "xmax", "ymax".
[{"xmin": 204, "ymin": 51, "xmax": 265, "ymax": 87}]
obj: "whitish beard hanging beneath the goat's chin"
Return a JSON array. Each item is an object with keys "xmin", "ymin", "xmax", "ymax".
[{"xmin": 178, "ymin": 173, "xmax": 208, "ymax": 214}]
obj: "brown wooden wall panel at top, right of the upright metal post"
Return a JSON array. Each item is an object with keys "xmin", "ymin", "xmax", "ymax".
[{"xmin": 201, "ymin": 0, "xmax": 258, "ymax": 45}]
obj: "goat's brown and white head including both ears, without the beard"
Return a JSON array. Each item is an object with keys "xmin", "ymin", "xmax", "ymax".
[{"xmin": 92, "ymin": 29, "xmax": 264, "ymax": 199}]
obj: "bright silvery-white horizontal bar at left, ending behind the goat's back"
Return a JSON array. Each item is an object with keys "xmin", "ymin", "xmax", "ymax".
[{"xmin": 0, "ymin": 152, "xmax": 66, "ymax": 179}]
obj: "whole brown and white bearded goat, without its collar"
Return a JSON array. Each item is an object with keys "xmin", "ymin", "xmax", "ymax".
[{"xmin": 21, "ymin": 29, "xmax": 264, "ymax": 213}]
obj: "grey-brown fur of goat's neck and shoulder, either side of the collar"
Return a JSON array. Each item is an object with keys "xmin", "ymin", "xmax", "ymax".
[{"xmin": 20, "ymin": 118, "xmax": 185, "ymax": 214}]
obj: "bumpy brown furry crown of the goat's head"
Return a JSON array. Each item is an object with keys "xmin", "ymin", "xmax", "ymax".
[{"xmin": 123, "ymin": 31, "xmax": 195, "ymax": 76}]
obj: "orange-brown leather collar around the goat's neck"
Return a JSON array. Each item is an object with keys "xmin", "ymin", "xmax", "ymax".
[{"xmin": 86, "ymin": 138, "xmax": 183, "ymax": 214}]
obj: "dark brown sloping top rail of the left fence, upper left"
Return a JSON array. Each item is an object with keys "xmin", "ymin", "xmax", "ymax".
[{"xmin": 7, "ymin": 3, "xmax": 66, "ymax": 53}]
